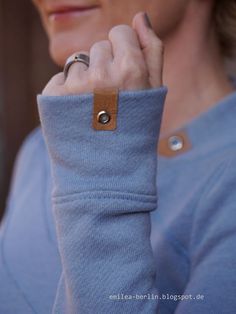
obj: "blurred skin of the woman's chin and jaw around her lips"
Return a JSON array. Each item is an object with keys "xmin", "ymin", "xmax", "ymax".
[{"xmin": 34, "ymin": 0, "xmax": 188, "ymax": 65}]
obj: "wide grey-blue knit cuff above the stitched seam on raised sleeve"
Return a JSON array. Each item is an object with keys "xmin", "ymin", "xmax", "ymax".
[{"xmin": 37, "ymin": 87, "xmax": 167, "ymax": 197}]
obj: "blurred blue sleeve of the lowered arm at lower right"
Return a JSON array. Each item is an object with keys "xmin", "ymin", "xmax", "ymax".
[{"xmin": 175, "ymin": 154, "xmax": 236, "ymax": 314}]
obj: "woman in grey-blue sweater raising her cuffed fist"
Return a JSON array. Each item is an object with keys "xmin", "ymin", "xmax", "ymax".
[{"xmin": 0, "ymin": 0, "xmax": 236, "ymax": 314}]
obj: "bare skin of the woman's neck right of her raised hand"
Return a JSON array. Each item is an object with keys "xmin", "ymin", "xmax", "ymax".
[{"xmin": 161, "ymin": 1, "xmax": 233, "ymax": 136}]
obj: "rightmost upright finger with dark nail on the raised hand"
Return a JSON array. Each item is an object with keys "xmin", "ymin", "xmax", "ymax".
[{"xmin": 132, "ymin": 12, "xmax": 164, "ymax": 88}]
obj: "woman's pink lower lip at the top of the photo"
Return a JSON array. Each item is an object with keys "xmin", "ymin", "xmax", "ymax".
[{"xmin": 49, "ymin": 7, "xmax": 98, "ymax": 22}]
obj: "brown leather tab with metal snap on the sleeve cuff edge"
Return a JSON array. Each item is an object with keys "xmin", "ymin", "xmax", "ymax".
[{"xmin": 93, "ymin": 88, "xmax": 119, "ymax": 131}]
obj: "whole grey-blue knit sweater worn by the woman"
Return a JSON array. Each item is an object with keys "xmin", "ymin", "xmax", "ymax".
[{"xmin": 0, "ymin": 87, "xmax": 236, "ymax": 314}]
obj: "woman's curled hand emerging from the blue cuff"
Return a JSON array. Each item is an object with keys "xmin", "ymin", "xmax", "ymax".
[{"xmin": 43, "ymin": 12, "xmax": 163, "ymax": 96}]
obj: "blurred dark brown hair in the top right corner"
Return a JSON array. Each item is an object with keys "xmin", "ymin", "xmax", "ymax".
[{"xmin": 214, "ymin": 0, "xmax": 236, "ymax": 58}]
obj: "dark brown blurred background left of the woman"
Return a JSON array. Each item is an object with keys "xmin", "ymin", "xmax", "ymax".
[{"xmin": 0, "ymin": 0, "xmax": 58, "ymax": 219}]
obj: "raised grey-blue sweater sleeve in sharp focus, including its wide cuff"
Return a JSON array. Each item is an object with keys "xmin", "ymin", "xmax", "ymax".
[{"xmin": 38, "ymin": 87, "xmax": 167, "ymax": 314}]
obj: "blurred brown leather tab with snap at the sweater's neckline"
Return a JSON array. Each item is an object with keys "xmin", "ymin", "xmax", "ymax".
[{"xmin": 158, "ymin": 130, "xmax": 192, "ymax": 157}]
